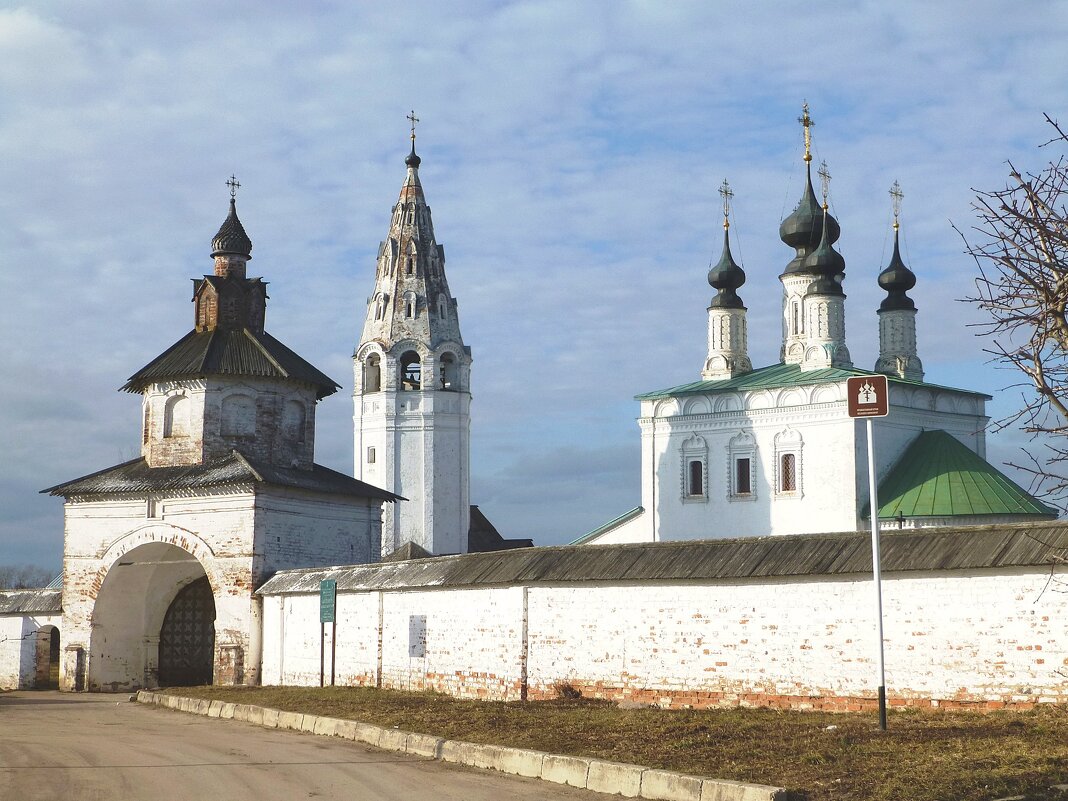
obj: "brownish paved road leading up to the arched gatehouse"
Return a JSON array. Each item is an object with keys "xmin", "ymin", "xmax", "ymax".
[{"xmin": 0, "ymin": 692, "xmax": 607, "ymax": 801}]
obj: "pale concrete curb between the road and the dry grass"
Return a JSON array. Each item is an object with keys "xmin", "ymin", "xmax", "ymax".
[{"xmin": 137, "ymin": 690, "xmax": 787, "ymax": 801}]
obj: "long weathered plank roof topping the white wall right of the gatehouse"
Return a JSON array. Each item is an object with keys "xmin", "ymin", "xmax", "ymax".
[{"xmin": 258, "ymin": 522, "xmax": 1068, "ymax": 595}]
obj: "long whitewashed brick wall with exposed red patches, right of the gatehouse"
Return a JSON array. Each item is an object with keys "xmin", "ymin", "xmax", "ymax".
[{"xmin": 263, "ymin": 568, "xmax": 1068, "ymax": 709}]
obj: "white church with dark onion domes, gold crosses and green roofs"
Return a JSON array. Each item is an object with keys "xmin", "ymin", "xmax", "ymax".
[{"xmin": 576, "ymin": 106, "xmax": 1056, "ymax": 545}]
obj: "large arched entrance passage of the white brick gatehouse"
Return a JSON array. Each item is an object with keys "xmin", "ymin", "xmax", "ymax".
[{"xmin": 88, "ymin": 541, "xmax": 216, "ymax": 692}]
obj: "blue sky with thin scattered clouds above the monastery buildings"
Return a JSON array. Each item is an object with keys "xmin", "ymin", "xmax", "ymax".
[{"xmin": 0, "ymin": 0, "xmax": 1068, "ymax": 569}]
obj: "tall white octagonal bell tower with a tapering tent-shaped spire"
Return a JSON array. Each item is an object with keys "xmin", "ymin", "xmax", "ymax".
[{"xmin": 352, "ymin": 112, "xmax": 471, "ymax": 556}]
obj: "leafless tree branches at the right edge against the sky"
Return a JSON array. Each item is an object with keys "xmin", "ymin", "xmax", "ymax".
[{"xmin": 957, "ymin": 114, "xmax": 1068, "ymax": 511}]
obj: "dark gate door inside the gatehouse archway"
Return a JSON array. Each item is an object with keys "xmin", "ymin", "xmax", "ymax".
[{"xmin": 159, "ymin": 576, "xmax": 215, "ymax": 687}]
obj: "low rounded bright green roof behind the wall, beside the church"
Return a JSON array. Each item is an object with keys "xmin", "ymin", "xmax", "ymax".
[{"xmin": 861, "ymin": 430, "xmax": 1057, "ymax": 519}]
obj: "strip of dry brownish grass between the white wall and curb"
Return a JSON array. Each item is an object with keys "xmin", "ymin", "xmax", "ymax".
[{"xmin": 166, "ymin": 687, "xmax": 1068, "ymax": 801}]
